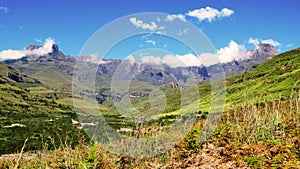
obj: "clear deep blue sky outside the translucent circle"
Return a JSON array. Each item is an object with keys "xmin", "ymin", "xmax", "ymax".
[{"xmin": 0, "ymin": 0, "xmax": 300, "ymax": 55}]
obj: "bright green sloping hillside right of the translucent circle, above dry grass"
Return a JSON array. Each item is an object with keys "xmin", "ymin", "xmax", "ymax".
[{"xmin": 226, "ymin": 49, "xmax": 300, "ymax": 107}]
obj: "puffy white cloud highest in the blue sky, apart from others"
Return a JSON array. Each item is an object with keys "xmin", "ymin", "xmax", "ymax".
[{"xmin": 186, "ymin": 7, "xmax": 234, "ymax": 22}]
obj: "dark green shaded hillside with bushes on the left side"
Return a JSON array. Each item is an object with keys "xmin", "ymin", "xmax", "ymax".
[{"xmin": 0, "ymin": 63, "xmax": 88, "ymax": 154}]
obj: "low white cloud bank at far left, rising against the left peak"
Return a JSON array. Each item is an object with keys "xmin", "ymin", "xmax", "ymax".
[{"xmin": 0, "ymin": 38, "xmax": 54, "ymax": 59}]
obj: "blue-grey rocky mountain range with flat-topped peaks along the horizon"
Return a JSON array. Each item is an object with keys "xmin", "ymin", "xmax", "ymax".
[{"xmin": 4, "ymin": 44, "xmax": 278, "ymax": 91}]
